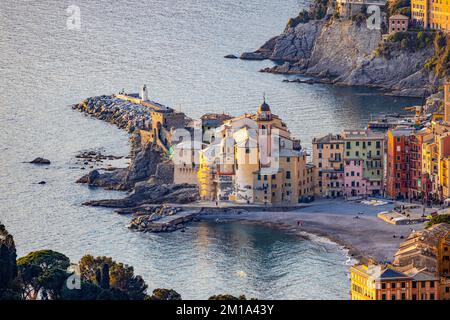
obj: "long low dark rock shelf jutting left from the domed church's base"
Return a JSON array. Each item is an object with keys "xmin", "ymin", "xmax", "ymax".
[{"xmin": 84, "ymin": 183, "xmax": 198, "ymax": 211}]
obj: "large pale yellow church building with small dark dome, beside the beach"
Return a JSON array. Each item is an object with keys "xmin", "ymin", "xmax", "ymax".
[{"xmin": 198, "ymin": 101, "xmax": 313, "ymax": 204}]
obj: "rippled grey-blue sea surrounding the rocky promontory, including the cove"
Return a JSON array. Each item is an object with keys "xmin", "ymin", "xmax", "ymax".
[{"xmin": 0, "ymin": 0, "xmax": 416, "ymax": 299}]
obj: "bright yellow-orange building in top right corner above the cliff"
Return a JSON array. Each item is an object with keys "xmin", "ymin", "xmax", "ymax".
[{"xmin": 411, "ymin": 0, "xmax": 450, "ymax": 31}]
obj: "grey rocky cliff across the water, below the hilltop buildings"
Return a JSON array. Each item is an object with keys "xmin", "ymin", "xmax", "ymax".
[{"xmin": 241, "ymin": 16, "xmax": 440, "ymax": 97}]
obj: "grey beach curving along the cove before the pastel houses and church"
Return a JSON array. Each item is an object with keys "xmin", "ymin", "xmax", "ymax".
[{"xmin": 205, "ymin": 199, "xmax": 423, "ymax": 261}]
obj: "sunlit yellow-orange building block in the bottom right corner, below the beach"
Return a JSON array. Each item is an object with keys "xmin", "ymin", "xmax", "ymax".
[{"xmin": 350, "ymin": 223, "xmax": 450, "ymax": 300}]
